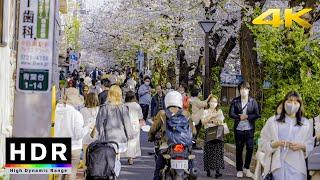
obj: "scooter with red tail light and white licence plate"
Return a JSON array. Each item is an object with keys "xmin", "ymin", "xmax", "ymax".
[{"xmin": 161, "ymin": 144, "xmax": 199, "ymax": 180}]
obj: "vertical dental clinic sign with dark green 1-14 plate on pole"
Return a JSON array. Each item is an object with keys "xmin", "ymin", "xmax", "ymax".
[{"xmin": 16, "ymin": 0, "xmax": 55, "ymax": 92}]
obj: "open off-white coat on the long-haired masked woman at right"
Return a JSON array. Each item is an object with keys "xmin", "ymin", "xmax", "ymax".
[{"xmin": 261, "ymin": 116, "xmax": 313, "ymax": 174}]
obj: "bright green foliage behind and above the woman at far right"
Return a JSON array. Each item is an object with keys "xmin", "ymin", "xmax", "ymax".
[{"xmin": 249, "ymin": 25, "xmax": 320, "ymax": 118}]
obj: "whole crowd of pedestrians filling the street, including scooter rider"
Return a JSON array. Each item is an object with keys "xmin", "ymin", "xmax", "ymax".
[{"xmin": 55, "ymin": 68, "xmax": 320, "ymax": 180}]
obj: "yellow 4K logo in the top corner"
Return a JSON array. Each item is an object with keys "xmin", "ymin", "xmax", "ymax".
[{"xmin": 252, "ymin": 9, "xmax": 312, "ymax": 28}]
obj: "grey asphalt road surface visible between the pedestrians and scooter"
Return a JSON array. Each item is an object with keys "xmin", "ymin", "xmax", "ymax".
[{"xmin": 77, "ymin": 129, "xmax": 250, "ymax": 180}]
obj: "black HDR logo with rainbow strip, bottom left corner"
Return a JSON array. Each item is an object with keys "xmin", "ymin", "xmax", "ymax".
[{"xmin": 5, "ymin": 138, "xmax": 71, "ymax": 174}]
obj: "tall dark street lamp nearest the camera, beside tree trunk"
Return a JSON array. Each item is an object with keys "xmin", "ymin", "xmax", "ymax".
[{"xmin": 199, "ymin": 20, "xmax": 216, "ymax": 98}]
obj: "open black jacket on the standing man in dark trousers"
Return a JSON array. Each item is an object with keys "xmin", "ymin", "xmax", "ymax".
[{"xmin": 229, "ymin": 96, "xmax": 260, "ymax": 131}]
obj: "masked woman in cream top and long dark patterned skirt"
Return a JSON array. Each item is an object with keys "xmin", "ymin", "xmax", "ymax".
[{"xmin": 201, "ymin": 96, "xmax": 224, "ymax": 178}]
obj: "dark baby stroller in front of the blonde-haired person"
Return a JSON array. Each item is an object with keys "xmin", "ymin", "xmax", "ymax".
[{"xmin": 85, "ymin": 140, "xmax": 121, "ymax": 180}]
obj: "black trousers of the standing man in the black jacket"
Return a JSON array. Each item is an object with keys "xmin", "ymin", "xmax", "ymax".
[{"xmin": 235, "ymin": 130, "xmax": 254, "ymax": 171}]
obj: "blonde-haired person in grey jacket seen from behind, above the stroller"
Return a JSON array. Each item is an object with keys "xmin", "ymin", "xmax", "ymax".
[{"xmin": 96, "ymin": 85, "xmax": 133, "ymax": 153}]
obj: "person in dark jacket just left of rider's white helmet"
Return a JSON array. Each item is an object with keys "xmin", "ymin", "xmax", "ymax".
[{"xmin": 151, "ymin": 85, "xmax": 165, "ymax": 118}]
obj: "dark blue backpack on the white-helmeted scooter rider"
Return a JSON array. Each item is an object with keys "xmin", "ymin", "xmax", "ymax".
[{"xmin": 165, "ymin": 109, "xmax": 192, "ymax": 146}]
